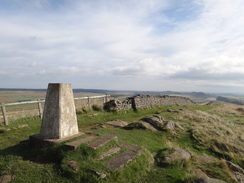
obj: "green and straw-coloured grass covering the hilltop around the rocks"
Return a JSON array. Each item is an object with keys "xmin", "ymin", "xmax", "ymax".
[{"xmin": 0, "ymin": 104, "xmax": 244, "ymax": 183}]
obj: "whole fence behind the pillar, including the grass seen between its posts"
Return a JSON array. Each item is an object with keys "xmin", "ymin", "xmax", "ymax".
[{"xmin": 0, "ymin": 95, "xmax": 110, "ymax": 125}]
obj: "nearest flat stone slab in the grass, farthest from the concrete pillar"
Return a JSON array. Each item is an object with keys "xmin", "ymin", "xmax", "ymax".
[{"xmin": 104, "ymin": 150, "xmax": 138, "ymax": 171}]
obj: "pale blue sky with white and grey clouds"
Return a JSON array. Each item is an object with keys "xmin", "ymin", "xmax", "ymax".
[{"xmin": 0, "ymin": 0, "xmax": 244, "ymax": 93}]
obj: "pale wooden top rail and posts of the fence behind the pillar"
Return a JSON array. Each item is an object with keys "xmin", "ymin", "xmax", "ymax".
[{"xmin": 1, "ymin": 94, "xmax": 110, "ymax": 125}]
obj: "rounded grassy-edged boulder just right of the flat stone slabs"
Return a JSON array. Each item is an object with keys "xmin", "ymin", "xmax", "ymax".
[{"xmin": 155, "ymin": 148, "xmax": 191, "ymax": 165}]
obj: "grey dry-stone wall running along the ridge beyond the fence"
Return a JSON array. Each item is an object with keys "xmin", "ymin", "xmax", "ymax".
[{"xmin": 104, "ymin": 95, "xmax": 195, "ymax": 111}]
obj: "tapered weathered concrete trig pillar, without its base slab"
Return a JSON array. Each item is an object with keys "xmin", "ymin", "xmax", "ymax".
[{"xmin": 40, "ymin": 83, "xmax": 79, "ymax": 139}]
